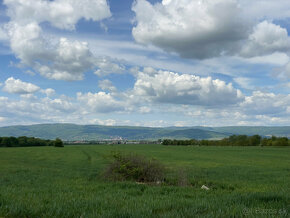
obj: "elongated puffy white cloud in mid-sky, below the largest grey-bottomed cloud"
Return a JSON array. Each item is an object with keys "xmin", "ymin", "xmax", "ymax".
[{"xmin": 133, "ymin": 68, "xmax": 243, "ymax": 106}]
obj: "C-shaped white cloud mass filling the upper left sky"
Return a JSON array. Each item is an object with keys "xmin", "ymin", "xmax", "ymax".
[{"xmin": 4, "ymin": 0, "xmax": 115, "ymax": 81}]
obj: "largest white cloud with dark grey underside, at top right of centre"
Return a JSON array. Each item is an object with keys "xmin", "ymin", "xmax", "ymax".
[{"xmin": 132, "ymin": 0, "xmax": 251, "ymax": 59}]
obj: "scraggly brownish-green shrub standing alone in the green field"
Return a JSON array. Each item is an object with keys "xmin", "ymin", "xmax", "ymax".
[{"xmin": 105, "ymin": 153, "xmax": 165, "ymax": 183}]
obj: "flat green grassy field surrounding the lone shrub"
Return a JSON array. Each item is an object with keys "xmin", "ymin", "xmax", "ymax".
[{"xmin": 0, "ymin": 145, "xmax": 290, "ymax": 218}]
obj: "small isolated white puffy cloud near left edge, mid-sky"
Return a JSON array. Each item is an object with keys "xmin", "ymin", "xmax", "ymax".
[{"xmin": 2, "ymin": 77, "xmax": 40, "ymax": 94}]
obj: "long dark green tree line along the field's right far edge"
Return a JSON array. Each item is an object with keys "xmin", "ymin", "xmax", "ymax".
[{"xmin": 162, "ymin": 135, "xmax": 290, "ymax": 146}]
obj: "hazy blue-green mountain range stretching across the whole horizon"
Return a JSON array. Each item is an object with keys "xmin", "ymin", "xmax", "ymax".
[{"xmin": 0, "ymin": 124, "xmax": 290, "ymax": 141}]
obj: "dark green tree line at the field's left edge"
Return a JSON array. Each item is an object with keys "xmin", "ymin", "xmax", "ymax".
[{"xmin": 0, "ymin": 136, "xmax": 63, "ymax": 147}]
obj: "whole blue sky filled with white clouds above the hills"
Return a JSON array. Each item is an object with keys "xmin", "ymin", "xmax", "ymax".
[{"xmin": 0, "ymin": 0, "xmax": 290, "ymax": 127}]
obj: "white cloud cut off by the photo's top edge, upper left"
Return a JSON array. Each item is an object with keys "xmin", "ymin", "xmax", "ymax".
[{"xmin": 4, "ymin": 0, "xmax": 111, "ymax": 30}]
